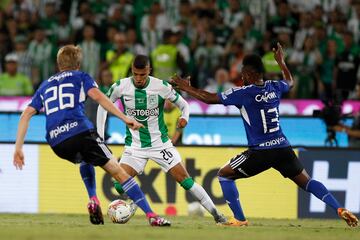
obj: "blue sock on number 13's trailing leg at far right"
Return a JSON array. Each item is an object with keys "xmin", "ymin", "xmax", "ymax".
[{"xmin": 305, "ymin": 179, "xmax": 341, "ymax": 211}]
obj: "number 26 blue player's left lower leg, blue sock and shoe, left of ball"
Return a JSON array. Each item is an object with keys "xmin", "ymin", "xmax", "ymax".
[{"xmin": 80, "ymin": 162, "xmax": 104, "ymax": 224}]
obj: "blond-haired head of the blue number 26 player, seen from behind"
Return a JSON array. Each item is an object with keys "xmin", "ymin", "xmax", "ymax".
[{"xmin": 56, "ymin": 45, "xmax": 82, "ymax": 71}]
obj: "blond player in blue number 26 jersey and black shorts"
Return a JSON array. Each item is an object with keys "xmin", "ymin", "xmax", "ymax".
[{"xmin": 13, "ymin": 45, "xmax": 170, "ymax": 226}]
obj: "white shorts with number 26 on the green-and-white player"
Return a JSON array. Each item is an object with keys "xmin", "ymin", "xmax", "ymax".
[{"xmin": 120, "ymin": 146, "xmax": 181, "ymax": 174}]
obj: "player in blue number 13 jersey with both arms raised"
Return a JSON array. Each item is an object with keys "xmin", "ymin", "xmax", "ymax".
[{"xmin": 171, "ymin": 43, "xmax": 358, "ymax": 227}]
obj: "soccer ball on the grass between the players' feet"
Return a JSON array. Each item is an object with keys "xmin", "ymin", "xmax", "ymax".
[{"xmin": 108, "ymin": 199, "xmax": 136, "ymax": 224}]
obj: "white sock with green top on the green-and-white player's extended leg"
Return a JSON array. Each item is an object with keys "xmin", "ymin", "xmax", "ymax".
[{"xmin": 180, "ymin": 178, "xmax": 220, "ymax": 218}]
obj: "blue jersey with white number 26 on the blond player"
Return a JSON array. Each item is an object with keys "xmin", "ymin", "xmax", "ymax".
[{"xmin": 29, "ymin": 71, "xmax": 97, "ymax": 146}]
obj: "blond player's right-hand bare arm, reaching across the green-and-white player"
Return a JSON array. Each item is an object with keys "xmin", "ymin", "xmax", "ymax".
[{"xmin": 88, "ymin": 88, "xmax": 144, "ymax": 130}]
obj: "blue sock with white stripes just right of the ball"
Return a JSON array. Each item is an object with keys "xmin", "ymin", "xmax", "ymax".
[{"xmin": 122, "ymin": 177, "xmax": 153, "ymax": 215}]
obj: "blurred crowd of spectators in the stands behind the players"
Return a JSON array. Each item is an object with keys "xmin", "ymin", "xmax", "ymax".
[{"xmin": 0, "ymin": 0, "xmax": 360, "ymax": 99}]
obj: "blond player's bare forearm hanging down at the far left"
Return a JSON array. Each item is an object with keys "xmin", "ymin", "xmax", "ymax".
[{"xmin": 13, "ymin": 106, "xmax": 36, "ymax": 170}]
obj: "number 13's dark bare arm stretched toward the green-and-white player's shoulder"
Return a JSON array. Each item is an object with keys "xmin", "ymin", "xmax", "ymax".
[{"xmin": 170, "ymin": 75, "xmax": 221, "ymax": 104}]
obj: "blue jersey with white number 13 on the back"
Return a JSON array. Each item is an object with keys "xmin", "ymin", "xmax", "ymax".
[{"xmin": 219, "ymin": 80, "xmax": 290, "ymax": 149}]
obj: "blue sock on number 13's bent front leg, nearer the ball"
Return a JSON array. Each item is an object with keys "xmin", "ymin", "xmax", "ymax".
[{"xmin": 218, "ymin": 177, "xmax": 246, "ymax": 221}]
